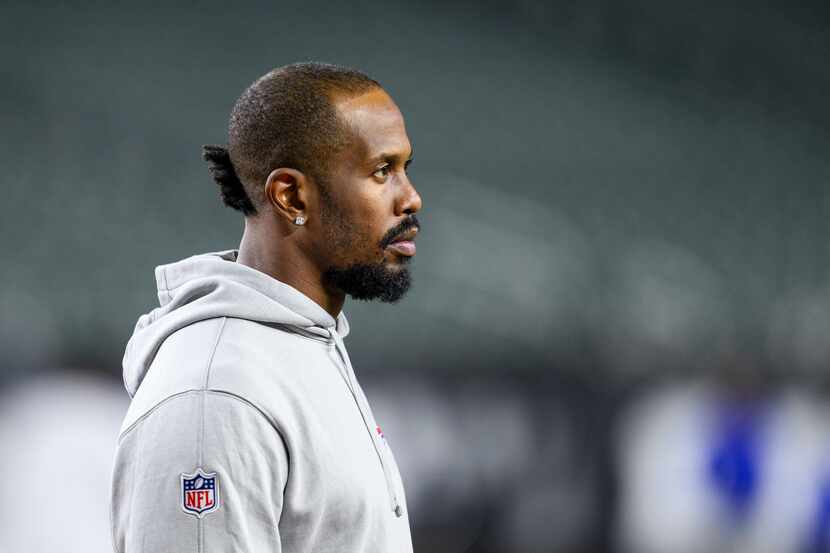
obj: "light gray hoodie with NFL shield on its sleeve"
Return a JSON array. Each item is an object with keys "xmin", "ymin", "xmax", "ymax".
[{"xmin": 112, "ymin": 250, "xmax": 412, "ymax": 553}]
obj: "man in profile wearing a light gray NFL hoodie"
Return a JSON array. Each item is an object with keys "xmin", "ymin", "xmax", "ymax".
[{"xmin": 112, "ymin": 63, "xmax": 421, "ymax": 553}]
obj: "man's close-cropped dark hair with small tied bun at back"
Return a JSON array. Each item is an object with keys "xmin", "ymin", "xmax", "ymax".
[{"xmin": 202, "ymin": 62, "xmax": 381, "ymax": 216}]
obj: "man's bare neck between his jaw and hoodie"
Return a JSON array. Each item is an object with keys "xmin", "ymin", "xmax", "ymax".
[{"xmin": 236, "ymin": 219, "xmax": 346, "ymax": 318}]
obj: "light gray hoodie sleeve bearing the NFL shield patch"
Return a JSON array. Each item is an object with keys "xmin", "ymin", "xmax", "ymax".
[{"xmin": 111, "ymin": 390, "xmax": 288, "ymax": 553}]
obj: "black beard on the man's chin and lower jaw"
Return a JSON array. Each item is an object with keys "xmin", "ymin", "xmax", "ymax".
[{"xmin": 323, "ymin": 258, "xmax": 412, "ymax": 303}]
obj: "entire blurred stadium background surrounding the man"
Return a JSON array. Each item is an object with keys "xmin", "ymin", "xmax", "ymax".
[{"xmin": 0, "ymin": 0, "xmax": 830, "ymax": 553}]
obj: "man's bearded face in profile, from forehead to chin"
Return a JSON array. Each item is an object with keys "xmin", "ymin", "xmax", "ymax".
[{"xmin": 318, "ymin": 89, "xmax": 421, "ymax": 302}]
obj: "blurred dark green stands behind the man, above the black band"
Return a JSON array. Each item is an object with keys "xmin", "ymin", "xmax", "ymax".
[{"xmin": 0, "ymin": 0, "xmax": 830, "ymax": 382}]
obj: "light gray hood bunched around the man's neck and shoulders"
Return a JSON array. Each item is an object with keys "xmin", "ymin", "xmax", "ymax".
[{"xmin": 122, "ymin": 250, "xmax": 349, "ymax": 397}]
